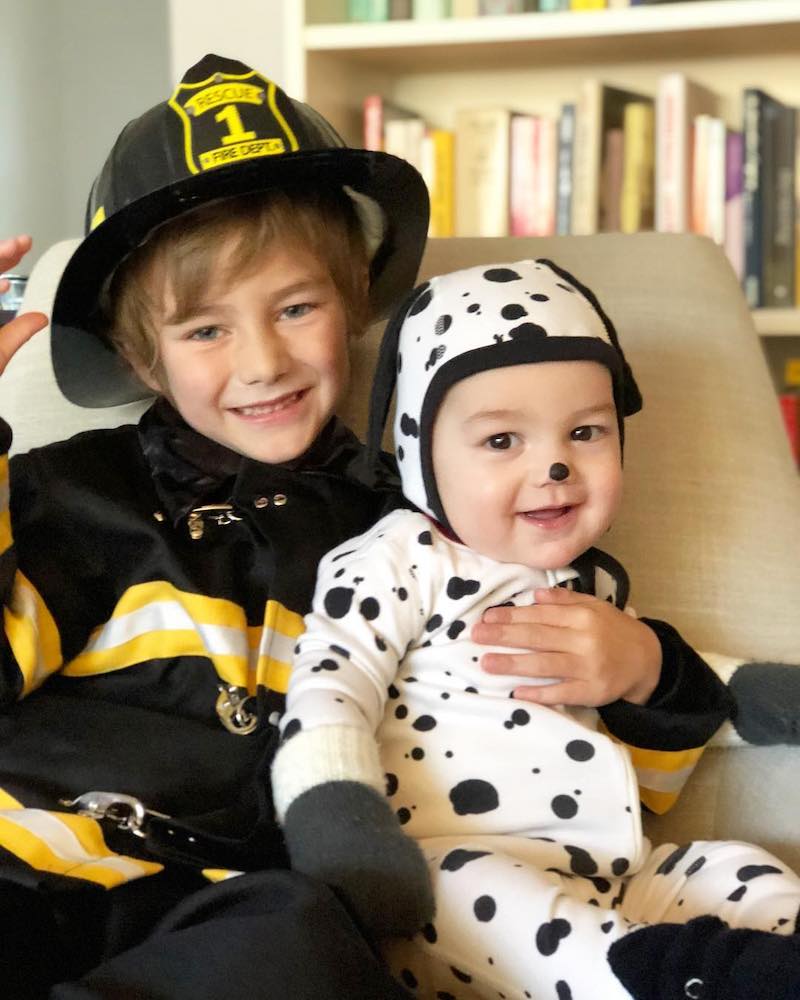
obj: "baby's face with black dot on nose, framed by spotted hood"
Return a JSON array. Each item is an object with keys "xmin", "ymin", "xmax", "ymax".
[{"xmin": 433, "ymin": 361, "xmax": 622, "ymax": 569}]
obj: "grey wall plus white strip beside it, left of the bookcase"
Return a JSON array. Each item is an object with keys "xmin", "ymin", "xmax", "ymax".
[{"xmin": 0, "ymin": 0, "xmax": 288, "ymax": 272}]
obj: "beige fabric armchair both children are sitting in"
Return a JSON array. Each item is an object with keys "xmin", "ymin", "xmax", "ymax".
[{"xmin": 6, "ymin": 234, "xmax": 800, "ymax": 870}]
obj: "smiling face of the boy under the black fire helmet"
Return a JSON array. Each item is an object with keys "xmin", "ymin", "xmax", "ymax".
[{"xmin": 139, "ymin": 247, "xmax": 349, "ymax": 464}]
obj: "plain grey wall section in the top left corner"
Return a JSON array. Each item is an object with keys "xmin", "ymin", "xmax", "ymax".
[{"xmin": 0, "ymin": 0, "xmax": 169, "ymax": 271}]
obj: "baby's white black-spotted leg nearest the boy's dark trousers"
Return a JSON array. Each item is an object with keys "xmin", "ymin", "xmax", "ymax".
[{"xmin": 387, "ymin": 842, "xmax": 630, "ymax": 1000}]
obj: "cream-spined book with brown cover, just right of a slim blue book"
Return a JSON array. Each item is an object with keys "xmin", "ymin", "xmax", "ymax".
[{"xmin": 572, "ymin": 78, "xmax": 652, "ymax": 235}]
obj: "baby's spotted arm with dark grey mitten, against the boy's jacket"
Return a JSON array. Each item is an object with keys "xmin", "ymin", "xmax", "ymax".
[{"xmin": 272, "ymin": 522, "xmax": 433, "ymax": 937}]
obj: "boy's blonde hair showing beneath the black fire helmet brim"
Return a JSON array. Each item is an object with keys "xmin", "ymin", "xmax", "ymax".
[{"xmin": 101, "ymin": 189, "xmax": 370, "ymax": 385}]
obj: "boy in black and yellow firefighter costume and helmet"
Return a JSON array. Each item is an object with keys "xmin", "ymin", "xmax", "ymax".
[{"xmin": 0, "ymin": 56, "xmax": 427, "ymax": 1000}]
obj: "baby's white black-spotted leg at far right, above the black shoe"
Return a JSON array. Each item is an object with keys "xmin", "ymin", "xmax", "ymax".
[{"xmin": 621, "ymin": 840, "xmax": 800, "ymax": 934}]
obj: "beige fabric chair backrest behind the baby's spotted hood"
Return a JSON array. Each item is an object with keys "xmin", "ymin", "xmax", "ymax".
[{"xmin": 343, "ymin": 233, "xmax": 800, "ymax": 663}]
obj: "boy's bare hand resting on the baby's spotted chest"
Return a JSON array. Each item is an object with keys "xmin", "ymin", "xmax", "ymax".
[{"xmin": 472, "ymin": 587, "xmax": 661, "ymax": 708}]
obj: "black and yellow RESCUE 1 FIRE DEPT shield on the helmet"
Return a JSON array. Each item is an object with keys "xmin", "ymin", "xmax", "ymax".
[{"xmin": 168, "ymin": 71, "xmax": 298, "ymax": 174}]
